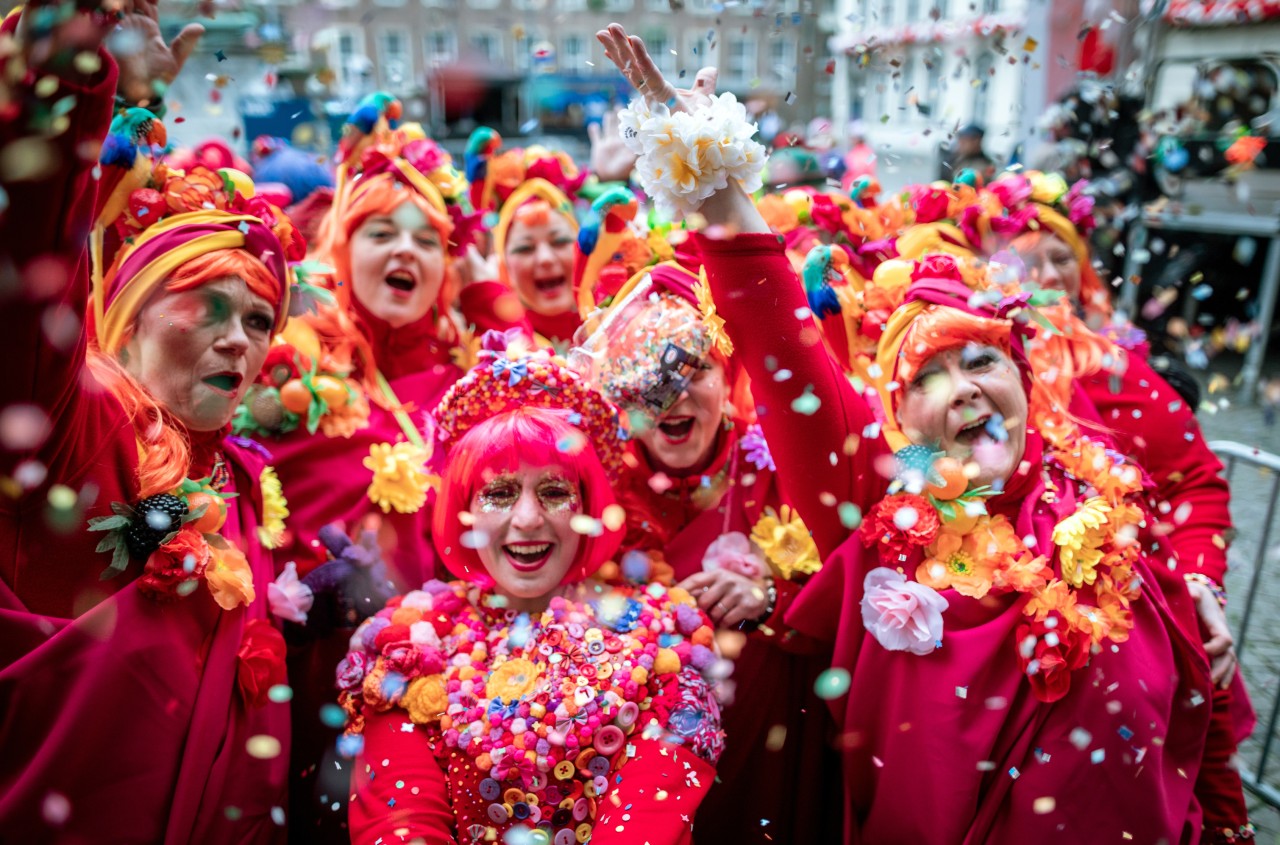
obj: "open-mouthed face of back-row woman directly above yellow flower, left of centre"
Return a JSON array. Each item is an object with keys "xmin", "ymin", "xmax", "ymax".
[{"xmin": 351, "ymin": 200, "xmax": 444, "ymax": 328}]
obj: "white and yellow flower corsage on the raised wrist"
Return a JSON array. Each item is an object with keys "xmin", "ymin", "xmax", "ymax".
[{"xmin": 618, "ymin": 93, "xmax": 768, "ymax": 218}]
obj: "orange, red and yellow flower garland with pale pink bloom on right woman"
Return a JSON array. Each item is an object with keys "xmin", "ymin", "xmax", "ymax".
[{"xmin": 860, "ymin": 435, "xmax": 1144, "ymax": 702}]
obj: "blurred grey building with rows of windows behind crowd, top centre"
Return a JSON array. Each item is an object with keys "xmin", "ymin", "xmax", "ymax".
[{"xmin": 278, "ymin": 0, "xmax": 833, "ymax": 143}]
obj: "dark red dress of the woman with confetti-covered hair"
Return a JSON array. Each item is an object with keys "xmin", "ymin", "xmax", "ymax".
[{"xmin": 625, "ymin": 414, "xmax": 841, "ymax": 844}]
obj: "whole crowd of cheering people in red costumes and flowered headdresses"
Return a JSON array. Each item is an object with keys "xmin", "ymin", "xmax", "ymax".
[{"xmin": 0, "ymin": 0, "xmax": 1253, "ymax": 845}]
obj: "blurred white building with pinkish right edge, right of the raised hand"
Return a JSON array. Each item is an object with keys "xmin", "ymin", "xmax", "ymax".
[{"xmin": 829, "ymin": 0, "xmax": 1084, "ymax": 187}]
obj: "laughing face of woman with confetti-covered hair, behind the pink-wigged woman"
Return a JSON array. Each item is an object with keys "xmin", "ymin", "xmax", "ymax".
[{"xmin": 640, "ymin": 358, "xmax": 728, "ymax": 478}]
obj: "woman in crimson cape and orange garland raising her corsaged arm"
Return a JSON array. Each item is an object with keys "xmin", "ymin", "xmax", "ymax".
[{"xmin": 604, "ymin": 27, "xmax": 1239, "ymax": 842}]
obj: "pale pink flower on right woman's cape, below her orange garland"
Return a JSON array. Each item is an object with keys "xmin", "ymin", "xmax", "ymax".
[{"xmin": 863, "ymin": 566, "xmax": 947, "ymax": 654}]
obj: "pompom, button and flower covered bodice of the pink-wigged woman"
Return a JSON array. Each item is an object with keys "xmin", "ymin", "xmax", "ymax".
[{"xmin": 338, "ymin": 581, "xmax": 723, "ymax": 841}]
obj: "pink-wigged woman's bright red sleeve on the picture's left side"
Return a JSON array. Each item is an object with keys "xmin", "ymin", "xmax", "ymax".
[{"xmin": 348, "ymin": 709, "xmax": 456, "ymax": 845}]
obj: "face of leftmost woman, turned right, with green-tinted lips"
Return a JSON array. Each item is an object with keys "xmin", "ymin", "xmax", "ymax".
[{"xmin": 120, "ymin": 277, "xmax": 275, "ymax": 431}]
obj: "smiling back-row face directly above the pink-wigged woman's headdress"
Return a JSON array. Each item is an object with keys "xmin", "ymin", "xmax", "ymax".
[{"xmin": 503, "ymin": 206, "xmax": 577, "ymax": 316}]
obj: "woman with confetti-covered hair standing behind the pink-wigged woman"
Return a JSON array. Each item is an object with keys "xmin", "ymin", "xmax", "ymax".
[{"xmin": 571, "ymin": 262, "xmax": 840, "ymax": 842}]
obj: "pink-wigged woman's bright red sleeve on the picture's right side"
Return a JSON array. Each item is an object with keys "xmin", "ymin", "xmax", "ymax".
[{"xmin": 591, "ymin": 739, "xmax": 716, "ymax": 845}]
